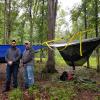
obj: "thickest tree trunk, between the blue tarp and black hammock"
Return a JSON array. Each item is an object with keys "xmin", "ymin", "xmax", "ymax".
[{"xmin": 46, "ymin": 0, "xmax": 58, "ymax": 73}]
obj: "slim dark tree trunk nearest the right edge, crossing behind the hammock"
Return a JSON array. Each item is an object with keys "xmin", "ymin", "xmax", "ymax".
[{"xmin": 95, "ymin": 0, "xmax": 100, "ymax": 72}]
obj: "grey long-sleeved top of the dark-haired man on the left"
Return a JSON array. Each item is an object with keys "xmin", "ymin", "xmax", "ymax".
[{"xmin": 5, "ymin": 47, "xmax": 21, "ymax": 64}]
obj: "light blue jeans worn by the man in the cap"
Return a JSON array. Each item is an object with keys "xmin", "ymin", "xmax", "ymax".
[{"xmin": 24, "ymin": 65, "xmax": 34, "ymax": 88}]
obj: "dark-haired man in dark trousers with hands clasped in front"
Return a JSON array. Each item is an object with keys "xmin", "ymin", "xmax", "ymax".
[{"xmin": 3, "ymin": 40, "xmax": 21, "ymax": 92}]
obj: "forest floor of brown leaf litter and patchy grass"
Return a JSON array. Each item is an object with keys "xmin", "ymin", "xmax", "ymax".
[{"xmin": 0, "ymin": 64, "xmax": 100, "ymax": 100}]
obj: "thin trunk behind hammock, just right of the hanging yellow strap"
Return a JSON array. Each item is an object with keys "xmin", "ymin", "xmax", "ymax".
[{"xmin": 84, "ymin": 0, "xmax": 90, "ymax": 68}]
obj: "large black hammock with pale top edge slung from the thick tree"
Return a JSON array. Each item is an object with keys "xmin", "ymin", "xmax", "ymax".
[{"xmin": 52, "ymin": 38, "xmax": 100, "ymax": 69}]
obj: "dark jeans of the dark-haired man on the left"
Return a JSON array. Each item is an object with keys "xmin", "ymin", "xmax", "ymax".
[{"xmin": 6, "ymin": 64, "xmax": 19, "ymax": 88}]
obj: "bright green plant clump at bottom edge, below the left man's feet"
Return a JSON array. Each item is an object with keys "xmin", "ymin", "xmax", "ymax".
[{"xmin": 9, "ymin": 88, "xmax": 23, "ymax": 100}]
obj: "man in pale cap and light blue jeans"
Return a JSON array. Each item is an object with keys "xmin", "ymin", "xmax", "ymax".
[{"xmin": 22, "ymin": 41, "xmax": 34, "ymax": 89}]
